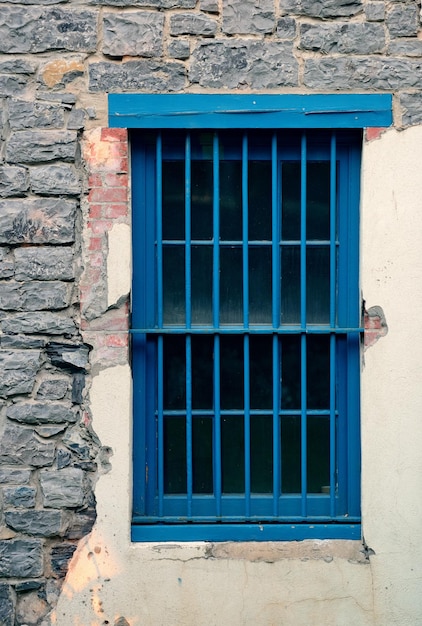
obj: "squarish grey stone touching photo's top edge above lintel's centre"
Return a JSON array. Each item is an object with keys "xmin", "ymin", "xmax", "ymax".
[{"xmin": 223, "ymin": 0, "xmax": 275, "ymax": 35}]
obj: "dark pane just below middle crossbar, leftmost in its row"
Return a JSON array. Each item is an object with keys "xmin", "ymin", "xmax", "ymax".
[{"xmin": 163, "ymin": 335, "xmax": 186, "ymax": 411}]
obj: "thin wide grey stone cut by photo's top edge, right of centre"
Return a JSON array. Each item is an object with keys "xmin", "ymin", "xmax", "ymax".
[{"xmin": 280, "ymin": 0, "xmax": 363, "ymax": 19}]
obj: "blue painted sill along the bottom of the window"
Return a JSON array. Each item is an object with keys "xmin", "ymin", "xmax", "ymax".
[{"xmin": 131, "ymin": 524, "xmax": 361, "ymax": 542}]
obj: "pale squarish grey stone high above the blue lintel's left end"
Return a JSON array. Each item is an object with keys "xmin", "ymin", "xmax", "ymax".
[{"xmin": 103, "ymin": 11, "xmax": 164, "ymax": 57}]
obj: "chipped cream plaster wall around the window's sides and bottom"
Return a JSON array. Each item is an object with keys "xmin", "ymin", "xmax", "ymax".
[{"xmin": 53, "ymin": 127, "xmax": 422, "ymax": 626}]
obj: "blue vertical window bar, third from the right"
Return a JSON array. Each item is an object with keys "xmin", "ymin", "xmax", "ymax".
[{"xmin": 271, "ymin": 133, "xmax": 282, "ymax": 517}]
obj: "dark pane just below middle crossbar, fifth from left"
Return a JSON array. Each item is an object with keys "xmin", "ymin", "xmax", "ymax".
[{"xmin": 281, "ymin": 335, "xmax": 301, "ymax": 410}]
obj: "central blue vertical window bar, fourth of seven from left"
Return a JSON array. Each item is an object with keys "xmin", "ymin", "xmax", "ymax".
[{"xmin": 242, "ymin": 132, "xmax": 251, "ymax": 517}]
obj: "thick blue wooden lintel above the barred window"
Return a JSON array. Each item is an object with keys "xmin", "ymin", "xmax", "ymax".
[{"xmin": 108, "ymin": 93, "xmax": 393, "ymax": 129}]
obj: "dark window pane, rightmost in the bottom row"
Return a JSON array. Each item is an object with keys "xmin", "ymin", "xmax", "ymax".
[{"xmin": 307, "ymin": 417, "xmax": 330, "ymax": 493}]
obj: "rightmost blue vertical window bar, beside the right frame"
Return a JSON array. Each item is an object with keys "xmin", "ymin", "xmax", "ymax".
[{"xmin": 330, "ymin": 131, "xmax": 337, "ymax": 518}]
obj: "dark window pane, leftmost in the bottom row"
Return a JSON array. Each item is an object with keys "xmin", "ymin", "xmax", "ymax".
[{"xmin": 164, "ymin": 417, "xmax": 186, "ymax": 493}]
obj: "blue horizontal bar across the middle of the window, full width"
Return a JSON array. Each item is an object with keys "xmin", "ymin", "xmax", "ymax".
[{"xmin": 128, "ymin": 325, "xmax": 365, "ymax": 335}]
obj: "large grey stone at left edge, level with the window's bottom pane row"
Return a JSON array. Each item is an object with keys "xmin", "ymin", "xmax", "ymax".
[{"xmin": 0, "ymin": 422, "xmax": 56, "ymax": 467}]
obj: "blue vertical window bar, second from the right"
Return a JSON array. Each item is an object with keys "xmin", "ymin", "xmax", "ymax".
[{"xmin": 300, "ymin": 132, "xmax": 308, "ymax": 517}]
